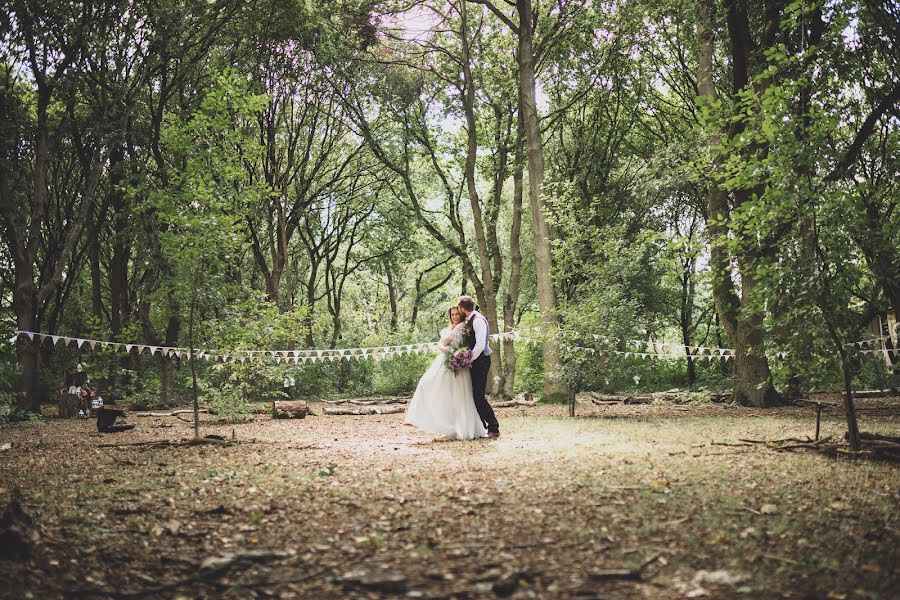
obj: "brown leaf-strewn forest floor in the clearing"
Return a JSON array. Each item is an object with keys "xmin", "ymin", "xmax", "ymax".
[{"xmin": 0, "ymin": 398, "xmax": 900, "ymax": 599}]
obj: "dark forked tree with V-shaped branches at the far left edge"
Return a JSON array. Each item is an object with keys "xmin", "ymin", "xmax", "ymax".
[{"xmin": 0, "ymin": 2, "xmax": 108, "ymax": 410}]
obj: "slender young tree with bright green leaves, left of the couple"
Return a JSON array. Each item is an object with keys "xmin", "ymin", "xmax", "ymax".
[{"xmin": 148, "ymin": 70, "xmax": 266, "ymax": 437}]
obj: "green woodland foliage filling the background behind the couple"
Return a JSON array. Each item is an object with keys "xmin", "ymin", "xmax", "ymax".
[{"xmin": 0, "ymin": 1, "xmax": 900, "ymax": 418}]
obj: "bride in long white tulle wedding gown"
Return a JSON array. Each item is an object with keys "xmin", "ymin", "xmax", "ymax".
[{"xmin": 405, "ymin": 306, "xmax": 486, "ymax": 440}]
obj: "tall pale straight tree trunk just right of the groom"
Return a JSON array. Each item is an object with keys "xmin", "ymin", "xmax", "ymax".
[{"xmin": 516, "ymin": 0, "xmax": 567, "ymax": 395}]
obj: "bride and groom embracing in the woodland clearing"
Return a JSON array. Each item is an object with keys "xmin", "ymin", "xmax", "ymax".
[{"xmin": 405, "ymin": 296, "xmax": 500, "ymax": 440}]
